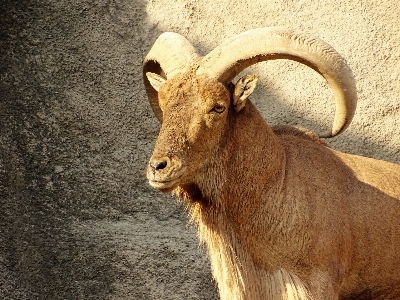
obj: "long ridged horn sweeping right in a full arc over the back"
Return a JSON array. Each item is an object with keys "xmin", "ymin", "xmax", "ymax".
[{"xmin": 197, "ymin": 27, "xmax": 357, "ymax": 137}]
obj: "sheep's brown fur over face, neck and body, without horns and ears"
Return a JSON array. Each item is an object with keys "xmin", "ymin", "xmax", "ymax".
[{"xmin": 148, "ymin": 72, "xmax": 400, "ymax": 299}]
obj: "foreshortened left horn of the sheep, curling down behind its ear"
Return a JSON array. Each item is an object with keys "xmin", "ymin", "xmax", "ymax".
[{"xmin": 143, "ymin": 32, "xmax": 199, "ymax": 123}]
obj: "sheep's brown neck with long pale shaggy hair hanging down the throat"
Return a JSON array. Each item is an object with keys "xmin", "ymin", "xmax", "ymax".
[{"xmin": 175, "ymin": 103, "xmax": 312, "ymax": 300}]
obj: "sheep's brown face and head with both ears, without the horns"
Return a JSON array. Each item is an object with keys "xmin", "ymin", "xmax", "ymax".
[{"xmin": 147, "ymin": 68, "xmax": 258, "ymax": 190}]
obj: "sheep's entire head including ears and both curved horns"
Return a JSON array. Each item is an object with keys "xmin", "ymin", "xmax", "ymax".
[{"xmin": 143, "ymin": 28, "xmax": 357, "ymax": 192}]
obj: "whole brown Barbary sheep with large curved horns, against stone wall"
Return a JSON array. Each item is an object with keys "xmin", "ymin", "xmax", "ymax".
[{"xmin": 143, "ymin": 28, "xmax": 400, "ymax": 300}]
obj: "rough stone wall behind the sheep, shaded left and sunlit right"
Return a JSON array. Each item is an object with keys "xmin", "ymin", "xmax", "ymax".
[{"xmin": 0, "ymin": 0, "xmax": 400, "ymax": 299}]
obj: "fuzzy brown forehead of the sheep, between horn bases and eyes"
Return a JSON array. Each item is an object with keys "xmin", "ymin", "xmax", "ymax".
[{"xmin": 159, "ymin": 73, "xmax": 230, "ymax": 106}]
